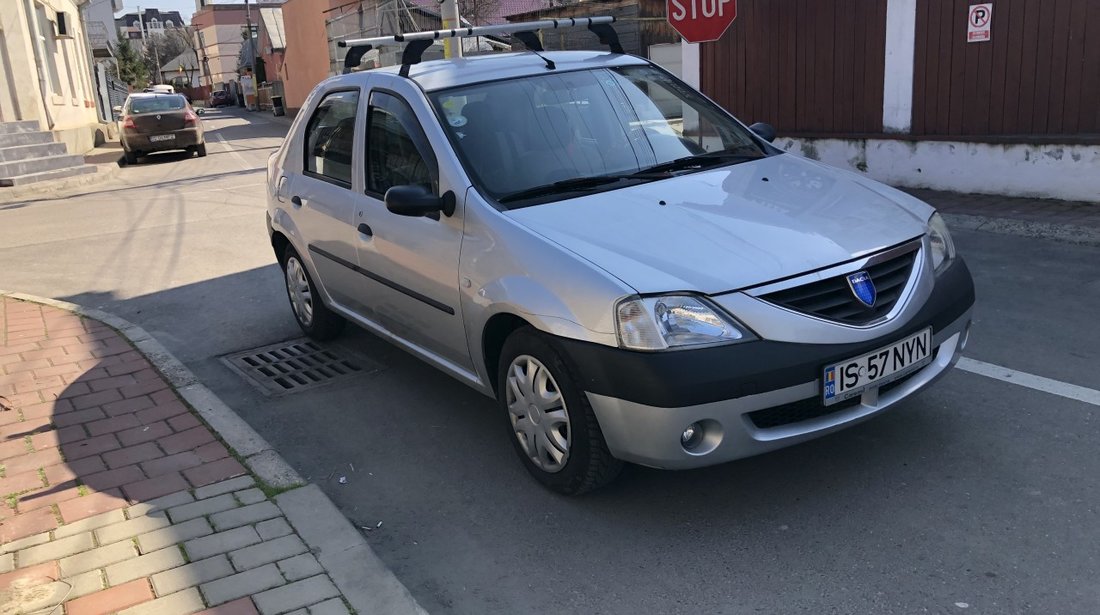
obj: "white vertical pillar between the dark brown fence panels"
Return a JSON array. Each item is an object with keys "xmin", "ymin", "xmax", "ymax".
[{"xmin": 882, "ymin": 0, "xmax": 916, "ymax": 133}]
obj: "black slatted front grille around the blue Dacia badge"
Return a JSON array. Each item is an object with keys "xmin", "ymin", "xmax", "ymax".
[{"xmin": 760, "ymin": 246, "xmax": 917, "ymax": 325}]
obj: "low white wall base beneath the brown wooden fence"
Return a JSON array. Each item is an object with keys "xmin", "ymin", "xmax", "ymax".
[{"xmin": 776, "ymin": 138, "xmax": 1100, "ymax": 202}]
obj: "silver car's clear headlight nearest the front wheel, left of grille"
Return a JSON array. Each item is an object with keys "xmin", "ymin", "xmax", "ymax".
[{"xmin": 616, "ymin": 295, "xmax": 751, "ymax": 350}]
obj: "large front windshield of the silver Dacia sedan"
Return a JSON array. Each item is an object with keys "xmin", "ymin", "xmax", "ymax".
[{"xmin": 431, "ymin": 66, "xmax": 766, "ymax": 207}]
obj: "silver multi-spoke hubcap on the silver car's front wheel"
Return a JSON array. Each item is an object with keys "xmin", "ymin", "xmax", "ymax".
[{"xmin": 505, "ymin": 354, "xmax": 572, "ymax": 472}]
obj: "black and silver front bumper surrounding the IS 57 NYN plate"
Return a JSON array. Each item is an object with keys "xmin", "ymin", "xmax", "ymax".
[{"xmin": 563, "ymin": 260, "xmax": 975, "ymax": 470}]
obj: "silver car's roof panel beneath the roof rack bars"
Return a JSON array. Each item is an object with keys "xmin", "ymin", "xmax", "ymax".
[{"xmin": 336, "ymin": 52, "xmax": 649, "ymax": 91}]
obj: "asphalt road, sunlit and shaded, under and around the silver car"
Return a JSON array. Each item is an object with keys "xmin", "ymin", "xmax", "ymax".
[{"xmin": 0, "ymin": 110, "xmax": 1100, "ymax": 614}]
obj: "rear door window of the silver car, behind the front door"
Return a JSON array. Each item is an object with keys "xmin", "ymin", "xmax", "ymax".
[{"xmin": 306, "ymin": 90, "xmax": 359, "ymax": 188}]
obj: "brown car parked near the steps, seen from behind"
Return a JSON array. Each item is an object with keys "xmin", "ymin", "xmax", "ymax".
[{"xmin": 117, "ymin": 94, "xmax": 206, "ymax": 164}]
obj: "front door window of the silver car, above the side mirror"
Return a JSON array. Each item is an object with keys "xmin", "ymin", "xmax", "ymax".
[{"xmin": 366, "ymin": 92, "xmax": 439, "ymax": 195}]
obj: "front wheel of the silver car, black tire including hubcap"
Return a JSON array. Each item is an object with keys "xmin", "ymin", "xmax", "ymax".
[{"xmin": 497, "ymin": 327, "xmax": 623, "ymax": 495}]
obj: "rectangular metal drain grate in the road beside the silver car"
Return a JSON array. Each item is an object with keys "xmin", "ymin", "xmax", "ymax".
[{"xmin": 222, "ymin": 339, "xmax": 375, "ymax": 395}]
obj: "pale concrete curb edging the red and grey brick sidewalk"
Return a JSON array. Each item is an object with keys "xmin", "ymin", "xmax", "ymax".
[{"xmin": 0, "ymin": 289, "xmax": 426, "ymax": 615}]
